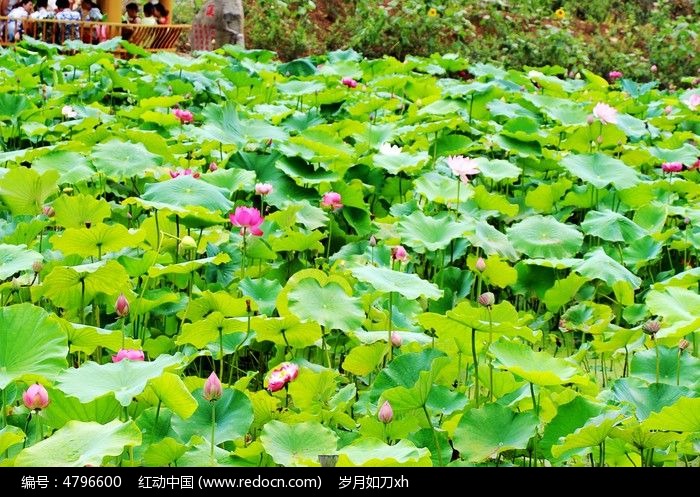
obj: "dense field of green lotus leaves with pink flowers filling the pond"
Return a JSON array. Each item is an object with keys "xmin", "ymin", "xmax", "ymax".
[{"xmin": 0, "ymin": 43, "xmax": 700, "ymax": 467}]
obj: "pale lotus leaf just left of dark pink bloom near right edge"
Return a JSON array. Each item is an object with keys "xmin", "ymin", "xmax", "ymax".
[{"xmin": 561, "ymin": 153, "xmax": 639, "ymax": 190}]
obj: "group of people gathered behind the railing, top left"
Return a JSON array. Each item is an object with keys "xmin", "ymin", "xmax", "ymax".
[{"xmin": 0, "ymin": 0, "xmax": 170, "ymax": 42}]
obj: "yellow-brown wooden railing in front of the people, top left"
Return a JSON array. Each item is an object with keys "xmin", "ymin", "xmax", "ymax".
[{"xmin": 0, "ymin": 17, "xmax": 191, "ymax": 51}]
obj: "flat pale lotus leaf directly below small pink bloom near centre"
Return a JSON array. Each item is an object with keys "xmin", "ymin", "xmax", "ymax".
[{"xmin": 350, "ymin": 266, "xmax": 443, "ymax": 300}]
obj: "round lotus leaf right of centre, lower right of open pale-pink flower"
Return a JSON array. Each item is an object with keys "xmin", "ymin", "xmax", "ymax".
[{"xmin": 508, "ymin": 216, "xmax": 583, "ymax": 259}]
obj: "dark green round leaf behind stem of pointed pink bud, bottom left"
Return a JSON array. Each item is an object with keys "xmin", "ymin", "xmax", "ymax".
[{"xmin": 173, "ymin": 388, "xmax": 253, "ymax": 444}]
